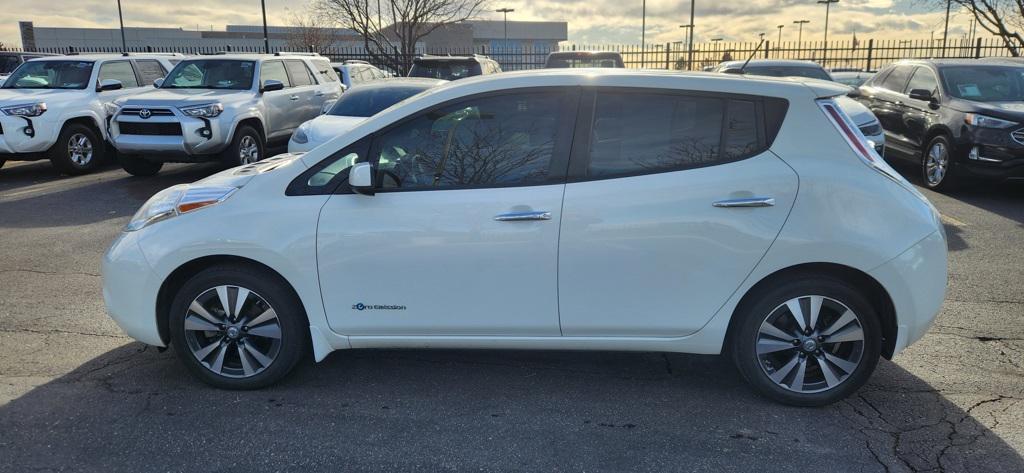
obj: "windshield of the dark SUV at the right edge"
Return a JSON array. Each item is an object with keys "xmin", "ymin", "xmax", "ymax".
[{"xmin": 939, "ymin": 66, "xmax": 1024, "ymax": 101}]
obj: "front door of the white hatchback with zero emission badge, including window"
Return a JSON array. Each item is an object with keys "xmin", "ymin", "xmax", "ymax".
[{"xmin": 316, "ymin": 89, "xmax": 577, "ymax": 336}]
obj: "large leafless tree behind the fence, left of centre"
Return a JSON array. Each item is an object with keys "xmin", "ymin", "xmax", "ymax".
[{"xmin": 316, "ymin": 0, "xmax": 488, "ymax": 72}]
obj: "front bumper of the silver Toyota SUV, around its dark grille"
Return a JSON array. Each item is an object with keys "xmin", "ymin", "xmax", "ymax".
[{"xmin": 109, "ymin": 105, "xmax": 232, "ymax": 162}]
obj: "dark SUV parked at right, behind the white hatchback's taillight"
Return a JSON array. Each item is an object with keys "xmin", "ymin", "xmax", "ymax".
[{"xmin": 857, "ymin": 59, "xmax": 1024, "ymax": 190}]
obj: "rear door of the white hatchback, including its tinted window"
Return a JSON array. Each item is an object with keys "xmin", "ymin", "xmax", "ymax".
[{"xmin": 558, "ymin": 89, "xmax": 798, "ymax": 337}]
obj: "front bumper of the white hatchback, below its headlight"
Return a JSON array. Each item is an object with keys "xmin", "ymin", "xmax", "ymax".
[{"xmin": 102, "ymin": 232, "xmax": 166, "ymax": 347}]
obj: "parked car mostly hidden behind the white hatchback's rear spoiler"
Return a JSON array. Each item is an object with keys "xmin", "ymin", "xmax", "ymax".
[{"xmin": 715, "ymin": 59, "xmax": 886, "ymax": 156}]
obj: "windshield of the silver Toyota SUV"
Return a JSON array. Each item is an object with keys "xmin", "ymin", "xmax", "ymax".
[{"xmin": 160, "ymin": 59, "xmax": 256, "ymax": 90}]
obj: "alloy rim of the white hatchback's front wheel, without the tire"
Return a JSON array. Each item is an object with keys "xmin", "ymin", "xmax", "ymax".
[{"xmin": 184, "ymin": 286, "xmax": 282, "ymax": 378}]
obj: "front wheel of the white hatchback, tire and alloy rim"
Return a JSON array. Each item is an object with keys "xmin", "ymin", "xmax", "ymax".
[{"xmin": 169, "ymin": 266, "xmax": 308, "ymax": 389}]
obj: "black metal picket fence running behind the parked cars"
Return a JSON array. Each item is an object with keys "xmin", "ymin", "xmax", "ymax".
[{"xmin": 4, "ymin": 38, "xmax": 1017, "ymax": 73}]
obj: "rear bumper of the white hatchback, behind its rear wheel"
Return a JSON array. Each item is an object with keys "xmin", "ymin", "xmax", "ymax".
[{"xmin": 868, "ymin": 230, "xmax": 948, "ymax": 355}]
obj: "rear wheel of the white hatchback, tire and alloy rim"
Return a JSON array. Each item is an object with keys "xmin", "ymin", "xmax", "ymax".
[{"xmin": 730, "ymin": 275, "xmax": 882, "ymax": 406}]
